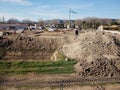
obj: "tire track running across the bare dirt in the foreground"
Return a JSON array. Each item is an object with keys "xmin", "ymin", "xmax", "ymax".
[{"xmin": 0, "ymin": 77, "xmax": 120, "ymax": 87}]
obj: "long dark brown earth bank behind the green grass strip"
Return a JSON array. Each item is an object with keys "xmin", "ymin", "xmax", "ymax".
[{"xmin": 0, "ymin": 35, "xmax": 71, "ymax": 60}]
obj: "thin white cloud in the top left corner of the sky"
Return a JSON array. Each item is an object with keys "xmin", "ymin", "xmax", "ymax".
[{"xmin": 0, "ymin": 0, "xmax": 32, "ymax": 5}]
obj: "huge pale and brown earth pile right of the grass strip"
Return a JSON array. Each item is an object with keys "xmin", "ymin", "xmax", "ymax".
[{"xmin": 61, "ymin": 31, "xmax": 120, "ymax": 77}]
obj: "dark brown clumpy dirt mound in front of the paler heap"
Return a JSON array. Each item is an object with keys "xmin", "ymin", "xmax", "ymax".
[{"xmin": 76, "ymin": 55, "xmax": 120, "ymax": 77}]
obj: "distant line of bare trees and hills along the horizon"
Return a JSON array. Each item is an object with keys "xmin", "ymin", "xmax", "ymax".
[{"xmin": 0, "ymin": 17, "xmax": 120, "ymax": 29}]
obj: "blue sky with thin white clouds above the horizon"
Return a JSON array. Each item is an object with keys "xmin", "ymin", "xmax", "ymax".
[{"xmin": 0, "ymin": 0, "xmax": 120, "ymax": 21}]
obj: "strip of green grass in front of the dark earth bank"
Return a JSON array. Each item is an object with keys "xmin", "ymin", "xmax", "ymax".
[{"xmin": 0, "ymin": 60, "xmax": 77, "ymax": 74}]
